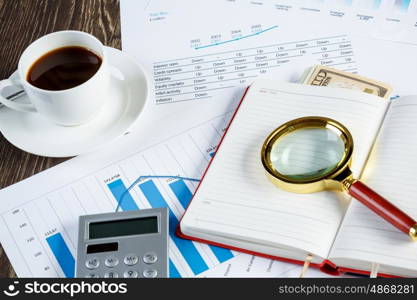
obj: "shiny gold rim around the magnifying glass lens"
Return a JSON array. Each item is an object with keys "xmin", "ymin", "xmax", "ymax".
[{"xmin": 261, "ymin": 116, "xmax": 353, "ymax": 186}]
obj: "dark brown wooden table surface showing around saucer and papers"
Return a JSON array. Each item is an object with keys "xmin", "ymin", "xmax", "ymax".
[{"xmin": 0, "ymin": 0, "xmax": 121, "ymax": 277}]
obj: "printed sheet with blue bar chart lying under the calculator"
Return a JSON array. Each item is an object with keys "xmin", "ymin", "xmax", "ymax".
[{"xmin": 0, "ymin": 111, "xmax": 234, "ymax": 278}]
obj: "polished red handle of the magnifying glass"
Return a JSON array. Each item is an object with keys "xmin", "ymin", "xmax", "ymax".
[{"xmin": 348, "ymin": 181, "xmax": 417, "ymax": 240}]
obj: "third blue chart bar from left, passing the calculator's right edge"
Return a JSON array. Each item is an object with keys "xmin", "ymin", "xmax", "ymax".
[{"xmin": 139, "ymin": 180, "xmax": 208, "ymax": 275}]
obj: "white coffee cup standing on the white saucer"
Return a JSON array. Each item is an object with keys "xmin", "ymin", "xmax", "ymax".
[{"xmin": 0, "ymin": 30, "xmax": 110, "ymax": 126}]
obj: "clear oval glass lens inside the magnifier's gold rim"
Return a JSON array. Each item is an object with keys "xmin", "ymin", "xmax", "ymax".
[{"xmin": 270, "ymin": 127, "xmax": 345, "ymax": 181}]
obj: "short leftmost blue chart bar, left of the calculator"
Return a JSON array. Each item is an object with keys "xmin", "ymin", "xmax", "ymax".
[{"xmin": 46, "ymin": 233, "xmax": 75, "ymax": 278}]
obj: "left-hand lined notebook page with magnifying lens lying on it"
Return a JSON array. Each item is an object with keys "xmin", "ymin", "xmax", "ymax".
[{"xmin": 181, "ymin": 79, "xmax": 388, "ymax": 257}]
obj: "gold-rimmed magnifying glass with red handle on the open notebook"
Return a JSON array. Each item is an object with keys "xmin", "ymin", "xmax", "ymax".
[{"xmin": 261, "ymin": 117, "xmax": 417, "ymax": 241}]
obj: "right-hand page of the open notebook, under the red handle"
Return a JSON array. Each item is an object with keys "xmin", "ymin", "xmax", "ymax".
[{"xmin": 330, "ymin": 97, "xmax": 417, "ymax": 276}]
